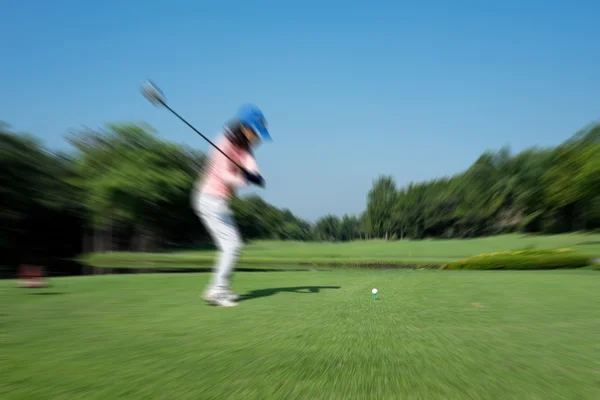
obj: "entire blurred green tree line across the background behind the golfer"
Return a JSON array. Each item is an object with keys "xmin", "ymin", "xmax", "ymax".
[{"xmin": 0, "ymin": 119, "xmax": 600, "ymax": 259}]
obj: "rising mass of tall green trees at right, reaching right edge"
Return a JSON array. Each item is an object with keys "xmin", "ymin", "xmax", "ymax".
[{"xmin": 361, "ymin": 124, "xmax": 600, "ymax": 239}]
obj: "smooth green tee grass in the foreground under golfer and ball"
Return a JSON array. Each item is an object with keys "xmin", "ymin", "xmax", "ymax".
[{"xmin": 0, "ymin": 270, "xmax": 600, "ymax": 400}]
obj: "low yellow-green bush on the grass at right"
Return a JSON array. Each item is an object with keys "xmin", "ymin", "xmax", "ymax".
[{"xmin": 442, "ymin": 249, "xmax": 590, "ymax": 270}]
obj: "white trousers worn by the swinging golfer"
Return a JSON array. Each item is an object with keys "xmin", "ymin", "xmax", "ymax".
[{"xmin": 193, "ymin": 191, "xmax": 242, "ymax": 290}]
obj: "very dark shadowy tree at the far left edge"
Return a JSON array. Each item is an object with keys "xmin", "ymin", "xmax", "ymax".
[{"xmin": 0, "ymin": 124, "xmax": 80, "ymax": 261}]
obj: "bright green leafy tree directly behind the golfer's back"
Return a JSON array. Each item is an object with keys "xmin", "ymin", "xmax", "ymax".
[{"xmin": 69, "ymin": 124, "xmax": 203, "ymax": 250}]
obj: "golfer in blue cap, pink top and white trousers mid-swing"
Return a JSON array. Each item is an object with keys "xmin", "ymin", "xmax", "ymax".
[{"xmin": 192, "ymin": 105, "xmax": 271, "ymax": 307}]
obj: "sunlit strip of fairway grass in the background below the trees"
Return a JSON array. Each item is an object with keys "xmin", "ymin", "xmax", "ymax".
[{"xmin": 85, "ymin": 234, "xmax": 600, "ymax": 268}]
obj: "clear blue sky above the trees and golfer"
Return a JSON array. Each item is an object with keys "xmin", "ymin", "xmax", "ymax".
[{"xmin": 0, "ymin": 0, "xmax": 600, "ymax": 219}]
